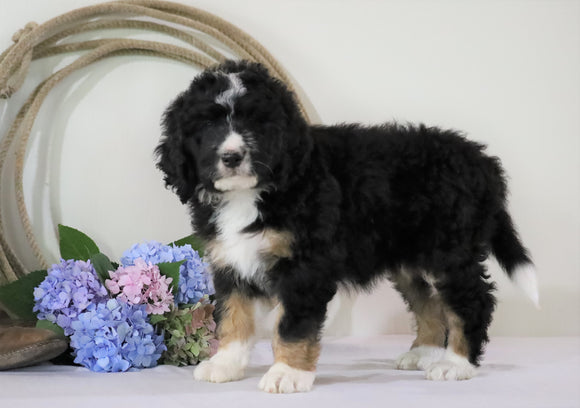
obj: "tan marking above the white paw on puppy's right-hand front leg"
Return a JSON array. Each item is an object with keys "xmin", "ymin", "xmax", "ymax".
[{"xmin": 272, "ymin": 305, "xmax": 320, "ymax": 371}]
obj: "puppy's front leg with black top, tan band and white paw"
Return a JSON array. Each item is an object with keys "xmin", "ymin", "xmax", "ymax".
[{"xmin": 259, "ymin": 305, "xmax": 324, "ymax": 393}]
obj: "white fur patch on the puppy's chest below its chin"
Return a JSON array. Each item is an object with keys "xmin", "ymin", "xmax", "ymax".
[{"xmin": 209, "ymin": 190, "xmax": 271, "ymax": 280}]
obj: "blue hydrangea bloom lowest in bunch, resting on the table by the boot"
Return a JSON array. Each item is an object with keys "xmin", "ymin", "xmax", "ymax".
[{"xmin": 70, "ymin": 299, "xmax": 167, "ymax": 372}]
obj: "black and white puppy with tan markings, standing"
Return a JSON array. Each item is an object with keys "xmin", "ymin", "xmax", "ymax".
[{"xmin": 157, "ymin": 61, "xmax": 537, "ymax": 392}]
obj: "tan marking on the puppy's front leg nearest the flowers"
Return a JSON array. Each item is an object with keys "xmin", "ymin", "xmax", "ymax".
[{"xmin": 218, "ymin": 293, "xmax": 255, "ymax": 348}]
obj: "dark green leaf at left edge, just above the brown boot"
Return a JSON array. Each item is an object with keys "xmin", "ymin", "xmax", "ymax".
[{"xmin": 0, "ymin": 271, "xmax": 47, "ymax": 321}]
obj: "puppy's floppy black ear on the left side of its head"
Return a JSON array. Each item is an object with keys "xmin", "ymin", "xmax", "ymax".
[{"xmin": 155, "ymin": 95, "xmax": 198, "ymax": 203}]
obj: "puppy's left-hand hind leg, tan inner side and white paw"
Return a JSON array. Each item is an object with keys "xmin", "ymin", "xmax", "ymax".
[{"xmin": 391, "ymin": 271, "xmax": 447, "ymax": 370}]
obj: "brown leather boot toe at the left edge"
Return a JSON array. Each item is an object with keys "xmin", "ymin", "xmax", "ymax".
[{"xmin": 0, "ymin": 326, "xmax": 68, "ymax": 370}]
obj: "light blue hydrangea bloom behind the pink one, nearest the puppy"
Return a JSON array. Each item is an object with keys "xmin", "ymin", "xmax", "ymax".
[{"xmin": 121, "ymin": 241, "xmax": 215, "ymax": 304}]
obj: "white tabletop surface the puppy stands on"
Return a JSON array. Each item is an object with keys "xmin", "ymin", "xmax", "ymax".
[{"xmin": 0, "ymin": 336, "xmax": 580, "ymax": 408}]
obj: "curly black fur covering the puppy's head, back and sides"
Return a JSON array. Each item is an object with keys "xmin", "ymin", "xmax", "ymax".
[{"xmin": 157, "ymin": 61, "xmax": 530, "ymax": 364}]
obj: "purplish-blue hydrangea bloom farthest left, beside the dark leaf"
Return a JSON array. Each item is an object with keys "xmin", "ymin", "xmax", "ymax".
[{"xmin": 32, "ymin": 260, "xmax": 108, "ymax": 336}]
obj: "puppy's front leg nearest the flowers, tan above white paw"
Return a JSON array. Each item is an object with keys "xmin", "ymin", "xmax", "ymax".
[{"xmin": 194, "ymin": 292, "xmax": 255, "ymax": 383}]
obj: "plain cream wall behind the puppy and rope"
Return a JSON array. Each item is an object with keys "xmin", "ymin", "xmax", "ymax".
[{"xmin": 0, "ymin": 0, "xmax": 580, "ymax": 336}]
